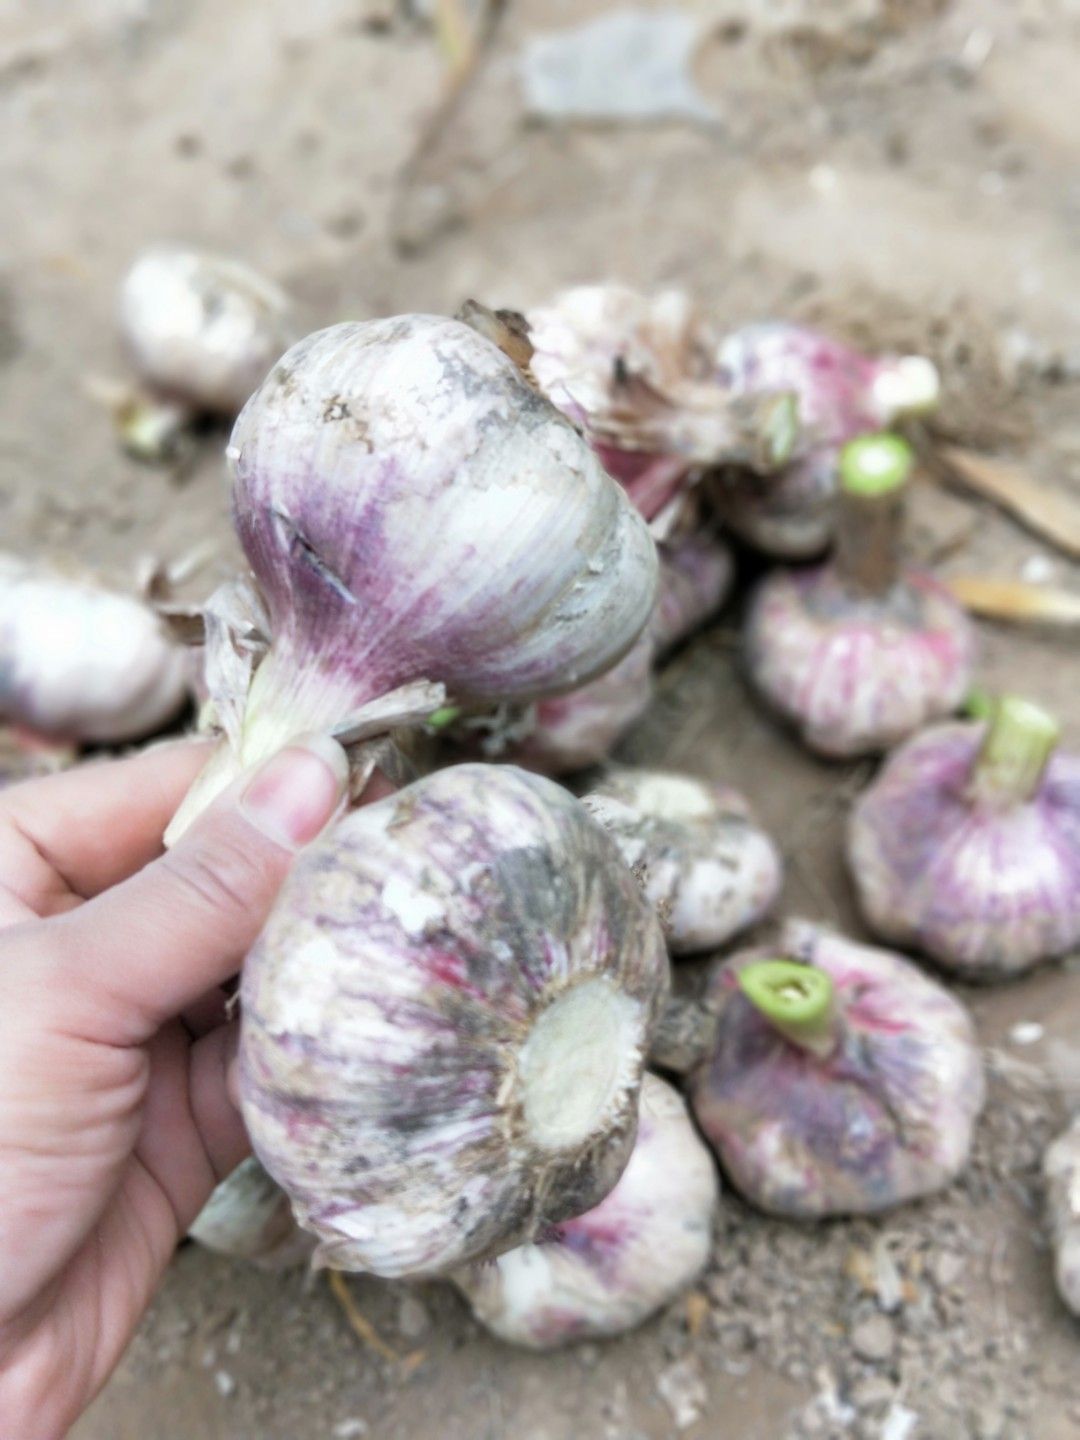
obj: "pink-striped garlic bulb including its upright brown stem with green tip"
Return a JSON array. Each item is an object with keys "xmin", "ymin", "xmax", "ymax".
[{"xmin": 746, "ymin": 435, "xmax": 975, "ymax": 756}]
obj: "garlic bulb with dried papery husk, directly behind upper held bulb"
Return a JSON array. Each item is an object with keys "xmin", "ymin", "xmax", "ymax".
[{"xmin": 526, "ymin": 285, "xmax": 798, "ymax": 521}]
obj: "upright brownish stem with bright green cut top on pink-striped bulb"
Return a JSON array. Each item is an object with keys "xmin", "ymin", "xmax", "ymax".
[{"xmin": 837, "ymin": 435, "xmax": 914, "ymax": 596}]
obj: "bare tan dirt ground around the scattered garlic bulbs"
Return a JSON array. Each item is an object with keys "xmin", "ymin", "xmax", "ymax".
[{"xmin": 0, "ymin": 0, "xmax": 1080, "ymax": 1440}]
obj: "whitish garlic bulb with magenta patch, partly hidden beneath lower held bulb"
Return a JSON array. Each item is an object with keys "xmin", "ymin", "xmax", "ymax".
[{"xmin": 454, "ymin": 1074, "xmax": 719, "ymax": 1351}]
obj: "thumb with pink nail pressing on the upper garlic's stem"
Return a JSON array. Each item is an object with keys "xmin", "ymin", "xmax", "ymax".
[{"xmin": 48, "ymin": 736, "xmax": 348, "ymax": 1044}]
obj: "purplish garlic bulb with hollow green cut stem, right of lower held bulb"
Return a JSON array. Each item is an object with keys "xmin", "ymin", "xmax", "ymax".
[{"xmin": 691, "ymin": 922, "xmax": 985, "ymax": 1218}]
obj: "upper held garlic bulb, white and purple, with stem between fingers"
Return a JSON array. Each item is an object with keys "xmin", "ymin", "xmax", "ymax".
[{"xmin": 173, "ymin": 315, "xmax": 657, "ymax": 834}]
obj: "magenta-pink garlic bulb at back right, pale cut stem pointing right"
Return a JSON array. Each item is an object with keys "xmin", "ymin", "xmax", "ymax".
[{"xmin": 714, "ymin": 321, "xmax": 940, "ymax": 560}]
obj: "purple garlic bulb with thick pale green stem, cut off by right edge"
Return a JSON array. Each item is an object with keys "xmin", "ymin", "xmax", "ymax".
[{"xmin": 847, "ymin": 696, "xmax": 1080, "ymax": 979}]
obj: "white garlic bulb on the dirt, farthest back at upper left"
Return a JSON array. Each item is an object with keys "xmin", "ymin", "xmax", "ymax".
[{"xmin": 120, "ymin": 245, "xmax": 295, "ymax": 418}]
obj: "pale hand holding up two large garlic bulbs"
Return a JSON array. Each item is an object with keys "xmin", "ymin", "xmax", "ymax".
[{"xmin": 0, "ymin": 737, "xmax": 347, "ymax": 1440}]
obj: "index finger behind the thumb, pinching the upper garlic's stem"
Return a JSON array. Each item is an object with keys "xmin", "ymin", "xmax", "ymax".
[{"xmin": 0, "ymin": 740, "xmax": 216, "ymax": 914}]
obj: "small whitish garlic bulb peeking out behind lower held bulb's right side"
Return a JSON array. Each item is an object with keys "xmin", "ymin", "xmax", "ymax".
[{"xmin": 583, "ymin": 769, "xmax": 780, "ymax": 955}]
